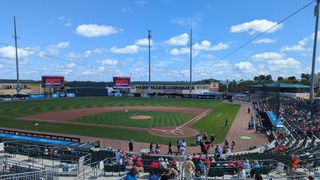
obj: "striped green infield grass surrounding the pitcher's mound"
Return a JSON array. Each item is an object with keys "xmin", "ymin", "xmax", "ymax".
[{"xmin": 76, "ymin": 110, "xmax": 194, "ymax": 128}]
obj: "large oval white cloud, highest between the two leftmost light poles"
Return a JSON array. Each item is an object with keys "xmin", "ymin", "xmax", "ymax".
[{"xmin": 76, "ymin": 24, "xmax": 122, "ymax": 37}]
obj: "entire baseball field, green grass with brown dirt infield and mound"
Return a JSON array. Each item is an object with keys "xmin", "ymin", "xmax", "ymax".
[{"xmin": 0, "ymin": 97, "xmax": 240, "ymax": 144}]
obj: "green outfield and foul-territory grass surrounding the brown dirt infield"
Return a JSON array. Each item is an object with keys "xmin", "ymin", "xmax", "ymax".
[{"xmin": 0, "ymin": 97, "xmax": 240, "ymax": 144}]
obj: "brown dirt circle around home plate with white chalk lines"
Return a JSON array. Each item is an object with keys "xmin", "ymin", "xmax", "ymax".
[{"xmin": 148, "ymin": 127, "xmax": 199, "ymax": 138}]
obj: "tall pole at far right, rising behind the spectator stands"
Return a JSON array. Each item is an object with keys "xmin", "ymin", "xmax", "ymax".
[{"xmin": 309, "ymin": 0, "xmax": 320, "ymax": 103}]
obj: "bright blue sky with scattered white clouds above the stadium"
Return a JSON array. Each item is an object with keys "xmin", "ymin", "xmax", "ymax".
[{"xmin": 0, "ymin": 0, "xmax": 320, "ymax": 81}]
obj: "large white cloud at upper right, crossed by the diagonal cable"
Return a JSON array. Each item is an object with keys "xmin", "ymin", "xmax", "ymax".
[{"xmin": 230, "ymin": 19, "xmax": 283, "ymax": 34}]
